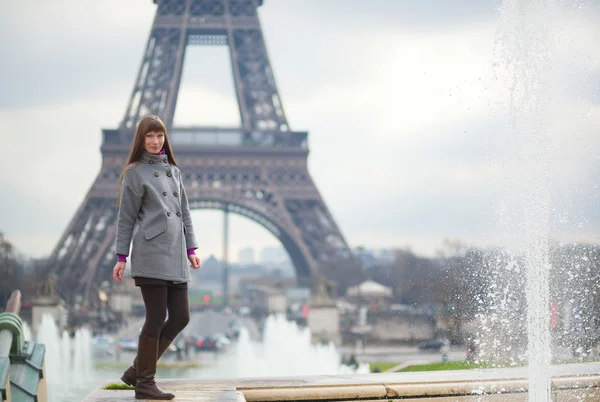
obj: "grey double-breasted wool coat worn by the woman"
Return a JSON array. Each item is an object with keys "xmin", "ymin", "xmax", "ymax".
[{"xmin": 116, "ymin": 151, "xmax": 198, "ymax": 282}]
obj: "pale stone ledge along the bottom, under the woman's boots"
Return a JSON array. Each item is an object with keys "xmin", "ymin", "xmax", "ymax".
[{"xmin": 84, "ymin": 363, "xmax": 600, "ymax": 402}]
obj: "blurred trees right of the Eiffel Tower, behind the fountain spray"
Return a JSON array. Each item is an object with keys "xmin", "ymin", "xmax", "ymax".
[{"xmin": 367, "ymin": 242, "xmax": 600, "ymax": 348}]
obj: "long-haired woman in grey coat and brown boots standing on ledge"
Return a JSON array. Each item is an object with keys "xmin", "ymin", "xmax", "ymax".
[{"xmin": 113, "ymin": 116, "xmax": 200, "ymax": 400}]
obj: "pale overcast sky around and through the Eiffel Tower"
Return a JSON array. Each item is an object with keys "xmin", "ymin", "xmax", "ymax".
[{"xmin": 0, "ymin": 0, "xmax": 600, "ymax": 260}]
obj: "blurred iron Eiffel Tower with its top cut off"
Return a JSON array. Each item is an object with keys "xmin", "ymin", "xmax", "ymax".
[{"xmin": 49, "ymin": 0, "xmax": 363, "ymax": 305}]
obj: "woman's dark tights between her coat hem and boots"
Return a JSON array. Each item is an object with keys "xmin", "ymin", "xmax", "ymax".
[{"xmin": 140, "ymin": 285, "xmax": 190, "ymax": 341}]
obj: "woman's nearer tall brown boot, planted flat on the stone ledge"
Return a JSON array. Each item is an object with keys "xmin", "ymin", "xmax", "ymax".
[{"xmin": 135, "ymin": 335, "xmax": 175, "ymax": 400}]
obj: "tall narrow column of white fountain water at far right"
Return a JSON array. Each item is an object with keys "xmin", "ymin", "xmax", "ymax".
[{"xmin": 500, "ymin": 0, "xmax": 558, "ymax": 402}]
